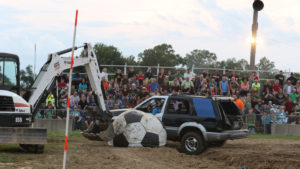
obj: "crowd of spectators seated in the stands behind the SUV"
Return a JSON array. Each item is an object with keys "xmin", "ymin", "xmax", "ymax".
[{"xmin": 36, "ymin": 67, "xmax": 300, "ymax": 132}]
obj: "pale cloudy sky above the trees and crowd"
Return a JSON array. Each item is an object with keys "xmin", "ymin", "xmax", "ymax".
[{"xmin": 0, "ymin": 0, "xmax": 300, "ymax": 72}]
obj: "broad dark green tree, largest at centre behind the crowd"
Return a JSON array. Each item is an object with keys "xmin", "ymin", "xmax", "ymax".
[{"xmin": 138, "ymin": 44, "xmax": 184, "ymax": 67}]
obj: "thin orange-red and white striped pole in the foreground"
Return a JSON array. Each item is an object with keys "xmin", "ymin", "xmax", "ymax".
[{"xmin": 63, "ymin": 9, "xmax": 78, "ymax": 169}]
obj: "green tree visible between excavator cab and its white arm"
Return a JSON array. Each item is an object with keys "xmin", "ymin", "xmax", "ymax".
[{"xmin": 20, "ymin": 65, "xmax": 34, "ymax": 90}]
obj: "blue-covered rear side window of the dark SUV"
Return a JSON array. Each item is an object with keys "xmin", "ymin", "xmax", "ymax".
[{"xmin": 193, "ymin": 98, "xmax": 216, "ymax": 118}]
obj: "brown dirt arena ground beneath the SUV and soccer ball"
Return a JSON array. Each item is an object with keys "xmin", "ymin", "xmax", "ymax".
[{"xmin": 0, "ymin": 139, "xmax": 300, "ymax": 169}]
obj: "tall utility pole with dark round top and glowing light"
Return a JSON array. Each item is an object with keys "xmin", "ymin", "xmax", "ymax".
[{"xmin": 250, "ymin": 0, "xmax": 264, "ymax": 70}]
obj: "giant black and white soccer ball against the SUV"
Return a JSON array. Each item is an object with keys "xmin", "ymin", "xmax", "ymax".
[{"xmin": 112, "ymin": 110, "xmax": 167, "ymax": 147}]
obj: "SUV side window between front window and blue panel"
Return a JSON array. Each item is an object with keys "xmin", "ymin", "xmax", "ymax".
[{"xmin": 167, "ymin": 99, "xmax": 190, "ymax": 114}]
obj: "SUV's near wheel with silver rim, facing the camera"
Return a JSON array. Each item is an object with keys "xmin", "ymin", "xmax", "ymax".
[{"xmin": 181, "ymin": 132, "xmax": 206, "ymax": 155}]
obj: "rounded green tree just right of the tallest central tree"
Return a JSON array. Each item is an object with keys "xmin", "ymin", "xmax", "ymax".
[{"xmin": 184, "ymin": 49, "xmax": 217, "ymax": 68}]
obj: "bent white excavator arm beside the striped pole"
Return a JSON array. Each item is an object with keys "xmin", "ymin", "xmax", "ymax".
[{"xmin": 28, "ymin": 44, "xmax": 107, "ymax": 113}]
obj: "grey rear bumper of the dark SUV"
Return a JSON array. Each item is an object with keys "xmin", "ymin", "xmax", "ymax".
[{"xmin": 206, "ymin": 129, "xmax": 248, "ymax": 142}]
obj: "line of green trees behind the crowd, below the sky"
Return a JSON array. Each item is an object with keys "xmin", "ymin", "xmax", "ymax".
[{"xmin": 20, "ymin": 43, "xmax": 275, "ymax": 90}]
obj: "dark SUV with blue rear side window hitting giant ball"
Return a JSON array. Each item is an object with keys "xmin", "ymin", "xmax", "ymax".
[{"xmin": 111, "ymin": 95, "xmax": 248, "ymax": 154}]
